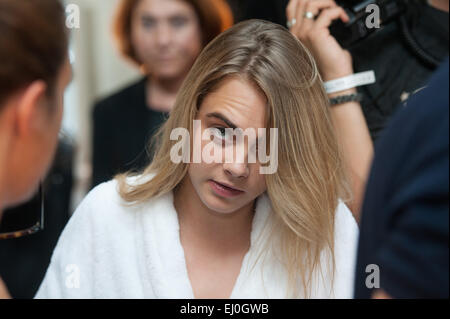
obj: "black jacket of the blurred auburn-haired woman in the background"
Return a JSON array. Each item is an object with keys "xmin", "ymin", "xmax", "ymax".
[{"xmin": 92, "ymin": 78, "xmax": 167, "ymax": 186}]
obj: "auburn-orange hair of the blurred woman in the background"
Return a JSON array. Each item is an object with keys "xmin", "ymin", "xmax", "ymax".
[{"xmin": 114, "ymin": 0, "xmax": 234, "ymax": 66}]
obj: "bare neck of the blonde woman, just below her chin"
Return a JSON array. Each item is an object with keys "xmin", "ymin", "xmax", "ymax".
[{"xmin": 174, "ymin": 177, "xmax": 254, "ymax": 254}]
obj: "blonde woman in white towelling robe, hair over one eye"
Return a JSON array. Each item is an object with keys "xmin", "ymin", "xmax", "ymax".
[{"xmin": 37, "ymin": 20, "xmax": 358, "ymax": 298}]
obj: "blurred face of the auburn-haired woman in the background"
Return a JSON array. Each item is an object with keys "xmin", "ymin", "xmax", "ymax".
[{"xmin": 131, "ymin": 0, "xmax": 203, "ymax": 79}]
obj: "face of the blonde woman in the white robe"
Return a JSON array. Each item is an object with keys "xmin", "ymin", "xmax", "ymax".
[{"xmin": 189, "ymin": 77, "xmax": 267, "ymax": 214}]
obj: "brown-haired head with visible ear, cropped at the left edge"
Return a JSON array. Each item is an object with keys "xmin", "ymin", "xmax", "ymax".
[{"xmin": 0, "ymin": 0, "xmax": 72, "ymax": 298}]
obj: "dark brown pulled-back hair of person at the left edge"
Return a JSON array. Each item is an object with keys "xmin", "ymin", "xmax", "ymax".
[{"xmin": 0, "ymin": 0, "xmax": 68, "ymax": 109}]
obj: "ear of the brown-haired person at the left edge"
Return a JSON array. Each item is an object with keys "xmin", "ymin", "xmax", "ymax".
[{"xmin": 16, "ymin": 80, "xmax": 47, "ymax": 135}]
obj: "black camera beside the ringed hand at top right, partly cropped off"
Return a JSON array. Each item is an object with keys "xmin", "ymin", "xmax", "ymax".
[{"xmin": 330, "ymin": 0, "xmax": 407, "ymax": 49}]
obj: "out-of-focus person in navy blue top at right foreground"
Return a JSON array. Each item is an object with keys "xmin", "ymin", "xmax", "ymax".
[{"xmin": 355, "ymin": 60, "xmax": 449, "ymax": 298}]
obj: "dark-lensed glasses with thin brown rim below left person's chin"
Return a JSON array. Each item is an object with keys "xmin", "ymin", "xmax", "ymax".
[{"xmin": 0, "ymin": 184, "xmax": 44, "ymax": 240}]
